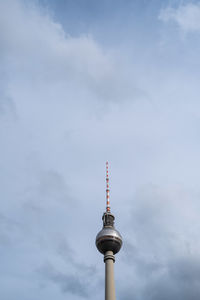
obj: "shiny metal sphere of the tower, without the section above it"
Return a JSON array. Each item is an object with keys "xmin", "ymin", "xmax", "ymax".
[{"xmin": 96, "ymin": 227, "xmax": 122, "ymax": 254}]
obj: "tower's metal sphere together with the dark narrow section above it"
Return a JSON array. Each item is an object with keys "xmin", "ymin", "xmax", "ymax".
[{"xmin": 96, "ymin": 213, "xmax": 122, "ymax": 254}]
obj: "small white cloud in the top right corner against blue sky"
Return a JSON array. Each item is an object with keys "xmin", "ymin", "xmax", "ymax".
[{"xmin": 159, "ymin": 3, "xmax": 200, "ymax": 33}]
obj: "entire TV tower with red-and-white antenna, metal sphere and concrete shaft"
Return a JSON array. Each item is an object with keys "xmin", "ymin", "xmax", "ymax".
[{"xmin": 96, "ymin": 162, "xmax": 122, "ymax": 300}]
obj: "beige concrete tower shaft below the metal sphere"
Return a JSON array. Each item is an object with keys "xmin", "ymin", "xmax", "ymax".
[{"xmin": 104, "ymin": 251, "xmax": 116, "ymax": 300}]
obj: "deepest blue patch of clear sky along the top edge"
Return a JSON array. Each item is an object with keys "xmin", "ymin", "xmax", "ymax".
[{"xmin": 40, "ymin": 0, "xmax": 166, "ymax": 45}]
